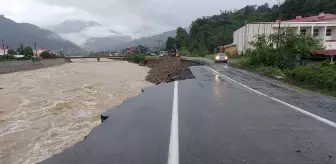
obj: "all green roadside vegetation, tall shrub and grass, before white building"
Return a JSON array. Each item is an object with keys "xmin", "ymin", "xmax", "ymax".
[{"xmin": 237, "ymin": 31, "xmax": 336, "ymax": 96}]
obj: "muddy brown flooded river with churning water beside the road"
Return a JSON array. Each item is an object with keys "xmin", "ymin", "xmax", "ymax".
[{"xmin": 0, "ymin": 60, "xmax": 152, "ymax": 164}]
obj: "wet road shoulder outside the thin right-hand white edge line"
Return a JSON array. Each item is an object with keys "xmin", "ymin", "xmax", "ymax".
[{"xmin": 182, "ymin": 57, "xmax": 336, "ymax": 122}]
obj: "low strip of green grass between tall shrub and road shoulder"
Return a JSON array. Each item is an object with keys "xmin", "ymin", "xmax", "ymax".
[{"xmin": 235, "ymin": 57, "xmax": 336, "ymax": 97}]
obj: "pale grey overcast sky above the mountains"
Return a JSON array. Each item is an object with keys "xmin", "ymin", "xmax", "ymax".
[{"xmin": 0, "ymin": 0, "xmax": 277, "ymax": 37}]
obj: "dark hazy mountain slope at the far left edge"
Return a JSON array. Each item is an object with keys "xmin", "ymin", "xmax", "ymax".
[{"xmin": 0, "ymin": 15, "xmax": 80, "ymax": 51}]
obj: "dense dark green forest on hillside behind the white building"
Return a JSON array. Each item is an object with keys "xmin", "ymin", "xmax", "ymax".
[{"xmin": 171, "ymin": 0, "xmax": 336, "ymax": 55}]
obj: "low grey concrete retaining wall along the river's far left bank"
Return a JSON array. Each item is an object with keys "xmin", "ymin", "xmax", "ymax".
[{"xmin": 0, "ymin": 58, "xmax": 65, "ymax": 74}]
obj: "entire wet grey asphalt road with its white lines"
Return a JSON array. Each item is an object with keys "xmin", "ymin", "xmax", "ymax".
[{"xmin": 42, "ymin": 65, "xmax": 336, "ymax": 164}]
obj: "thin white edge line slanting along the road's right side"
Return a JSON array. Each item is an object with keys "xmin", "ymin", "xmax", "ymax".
[{"xmin": 205, "ymin": 66, "xmax": 336, "ymax": 128}]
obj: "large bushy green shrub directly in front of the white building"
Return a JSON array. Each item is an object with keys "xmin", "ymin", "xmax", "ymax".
[{"xmin": 245, "ymin": 30, "xmax": 321, "ymax": 69}]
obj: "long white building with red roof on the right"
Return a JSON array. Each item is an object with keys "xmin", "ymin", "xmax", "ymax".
[{"xmin": 233, "ymin": 13, "xmax": 336, "ymax": 56}]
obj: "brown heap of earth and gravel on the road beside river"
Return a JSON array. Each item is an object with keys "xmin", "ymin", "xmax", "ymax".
[{"xmin": 146, "ymin": 57, "xmax": 200, "ymax": 84}]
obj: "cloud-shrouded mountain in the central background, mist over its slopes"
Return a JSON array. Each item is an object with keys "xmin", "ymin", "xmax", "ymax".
[{"xmin": 48, "ymin": 20, "xmax": 188, "ymax": 51}]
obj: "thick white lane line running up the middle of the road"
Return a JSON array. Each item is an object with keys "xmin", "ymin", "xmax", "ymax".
[{"xmin": 168, "ymin": 81, "xmax": 179, "ymax": 164}]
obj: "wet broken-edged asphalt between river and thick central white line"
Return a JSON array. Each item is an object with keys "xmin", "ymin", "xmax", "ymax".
[{"xmin": 42, "ymin": 83, "xmax": 173, "ymax": 164}]
